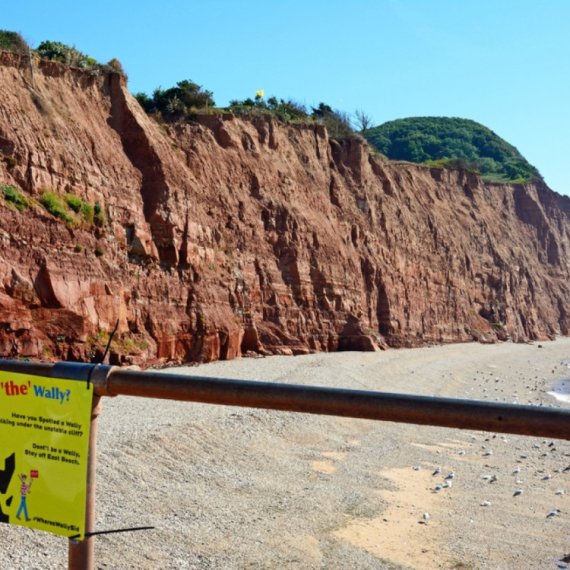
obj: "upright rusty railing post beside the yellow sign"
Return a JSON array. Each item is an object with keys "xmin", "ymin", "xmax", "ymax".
[{"xmin": 67, "ymin": 395, "xmax": 103, "ymax": 570}]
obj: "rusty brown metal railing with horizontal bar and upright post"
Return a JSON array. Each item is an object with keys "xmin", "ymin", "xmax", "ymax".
[{"xmin": 0, "ymin": 360, "xmax": 570, "ymax": 570}]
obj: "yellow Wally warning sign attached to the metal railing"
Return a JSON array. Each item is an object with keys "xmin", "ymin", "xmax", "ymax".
[{"xmin": 0, "ymin": 372, "xmax": 93, "ymax": 540}]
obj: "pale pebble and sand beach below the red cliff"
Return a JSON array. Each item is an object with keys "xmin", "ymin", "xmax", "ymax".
[{"xmin": 0, "ymin": 339, "xmax": 570, "ymax": 569}]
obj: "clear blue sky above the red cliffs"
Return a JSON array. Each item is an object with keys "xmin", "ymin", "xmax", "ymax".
[{"xmin": 4, "ymin": 0, "xmax": 570, "ymax": 195}]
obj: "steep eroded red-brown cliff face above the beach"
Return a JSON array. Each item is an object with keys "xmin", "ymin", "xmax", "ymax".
[{"xmin": 0, "ymin": 53, "xmax": 570, "ymax": 363}]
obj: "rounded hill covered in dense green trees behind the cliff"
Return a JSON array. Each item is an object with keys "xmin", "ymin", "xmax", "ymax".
[{"xmin": 364, "ymin": 117, "xmax": 542, "ymax": 183}]
